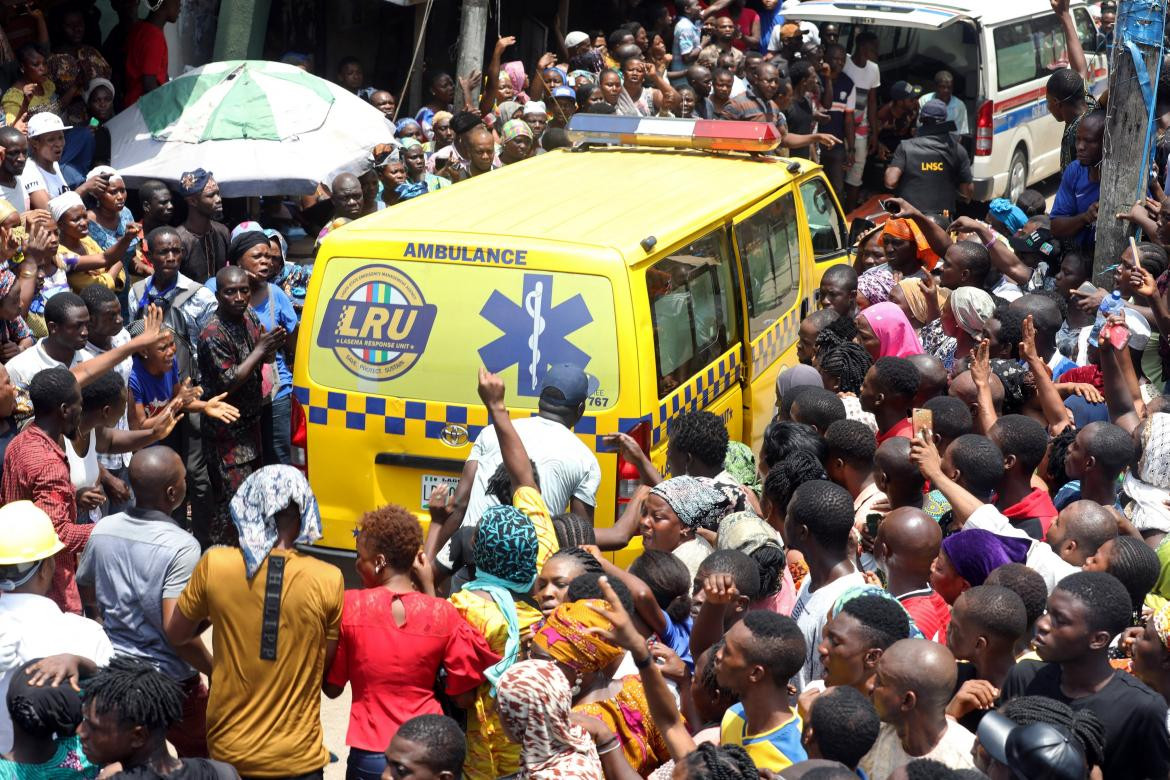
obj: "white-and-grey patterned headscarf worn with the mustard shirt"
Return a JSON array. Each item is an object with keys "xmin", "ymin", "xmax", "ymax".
[{"xmin": 229, "ymin": 465, "xmax": 321, "ymax": 579}]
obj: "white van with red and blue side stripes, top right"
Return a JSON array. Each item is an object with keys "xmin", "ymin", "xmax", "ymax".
[{"xmin": 786, "ymin": 0, "xmax": 1107, "ymax": 202}]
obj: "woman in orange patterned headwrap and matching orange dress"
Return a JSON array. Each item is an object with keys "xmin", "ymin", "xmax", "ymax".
[{"xmin": 530, "ymin": 599, "xmax": 670, "ymax": 776}]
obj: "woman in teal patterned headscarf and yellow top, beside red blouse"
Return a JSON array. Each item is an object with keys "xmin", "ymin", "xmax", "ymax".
[{"xmin": 450, "ymin": 504, "xmax": 556, "ymax": 780}]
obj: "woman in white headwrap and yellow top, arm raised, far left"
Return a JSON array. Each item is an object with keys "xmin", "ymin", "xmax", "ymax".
[{"xmin": 49, "ymin": 189, "xmax": 131, "ymax": 292}]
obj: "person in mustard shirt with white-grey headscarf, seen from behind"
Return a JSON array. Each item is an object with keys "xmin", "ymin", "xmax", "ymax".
[{"xmin": 166, "ymin": 465, "xmax": 345, "ymax": 776}]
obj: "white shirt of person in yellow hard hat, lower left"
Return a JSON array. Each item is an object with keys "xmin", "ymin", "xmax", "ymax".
[{"xmin": 0, "ymin": 593, "xmax": 113, "ymax": 753}]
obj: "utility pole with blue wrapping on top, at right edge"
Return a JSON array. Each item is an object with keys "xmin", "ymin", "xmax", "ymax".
[{"xmin": 1093, "ymin": 0, "xmax": 1166, "ymax": 279}]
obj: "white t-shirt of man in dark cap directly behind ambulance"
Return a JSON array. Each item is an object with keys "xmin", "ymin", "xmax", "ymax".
[{"xmin": 463, "ymin": 417, "xmax": 601, "ymax": 525}]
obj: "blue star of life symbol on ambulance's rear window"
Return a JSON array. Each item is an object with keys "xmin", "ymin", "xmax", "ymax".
[{"xmin": 479, "ymin": 274, "xmax": 593, "ymax": 396}]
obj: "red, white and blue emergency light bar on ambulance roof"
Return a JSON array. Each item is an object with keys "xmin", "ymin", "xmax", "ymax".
[{"xmin": 565, "ymin": 113, "xmax": 780, "ymax": 152}]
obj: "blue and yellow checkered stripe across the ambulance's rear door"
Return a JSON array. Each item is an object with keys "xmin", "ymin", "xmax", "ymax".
[{"xmin": 293, "ymin": 386, "xmax": 649, "ymax": 451}]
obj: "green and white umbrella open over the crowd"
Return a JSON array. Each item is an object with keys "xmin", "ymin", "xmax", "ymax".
[{"xmin": 106, "ymin": 60, "xmax": 393, "ymax": 198}]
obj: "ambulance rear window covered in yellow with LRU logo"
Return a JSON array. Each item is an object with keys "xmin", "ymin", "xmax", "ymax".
[{"xmin": 309, "ymin": 257, "xmax": 619, "ymax": 410}]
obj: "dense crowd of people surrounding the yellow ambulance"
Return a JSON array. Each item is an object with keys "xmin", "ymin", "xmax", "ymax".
[{"xmin": 0, "ymin": 0, "xmax": 1170, "ymax": 780}]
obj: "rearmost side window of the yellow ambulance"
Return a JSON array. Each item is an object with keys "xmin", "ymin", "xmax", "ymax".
[{"xmin": 646, "ymin": 229, "xmax": 739, "ymax": 398}]
